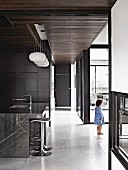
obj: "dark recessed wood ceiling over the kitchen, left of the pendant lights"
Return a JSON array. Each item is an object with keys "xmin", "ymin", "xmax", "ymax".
[{"xmin": 0, "ymin": 25, "xmax": 34, "ymax": 51}]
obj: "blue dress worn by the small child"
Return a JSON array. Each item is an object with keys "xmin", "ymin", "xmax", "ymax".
[{"xmin": 94, "ymin": 106, "xmax": 104, "ymax": 125}]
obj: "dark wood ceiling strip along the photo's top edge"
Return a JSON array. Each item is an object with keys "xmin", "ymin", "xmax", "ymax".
[{"xmin": 0, "ymin": 0, "xmax": 115, "ymax": 11}]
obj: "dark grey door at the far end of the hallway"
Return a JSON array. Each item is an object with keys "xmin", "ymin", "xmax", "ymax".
[{"xmin": 55, "ymin": 64, "xmax": 71, "ymax": 107}]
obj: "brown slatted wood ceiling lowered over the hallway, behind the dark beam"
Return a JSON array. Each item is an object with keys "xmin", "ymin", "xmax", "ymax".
[{"xmin": 6, "ymin": 15, "xmax": 108, "ymax": 63}]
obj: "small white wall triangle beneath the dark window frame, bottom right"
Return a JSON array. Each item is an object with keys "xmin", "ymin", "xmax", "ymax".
[{"xmin": 111, "ymin": 153, "xmax": 125, "ymax": 170}]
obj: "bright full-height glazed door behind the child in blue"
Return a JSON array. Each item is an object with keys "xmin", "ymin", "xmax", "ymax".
[{"xmin": 90, "ymin": 49, "xmax": 109, "ymax": 122}]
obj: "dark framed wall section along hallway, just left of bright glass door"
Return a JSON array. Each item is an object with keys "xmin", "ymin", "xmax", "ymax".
[{"xmin": 76, "ymin": 50, "xmax": 90, "ymax": 123}]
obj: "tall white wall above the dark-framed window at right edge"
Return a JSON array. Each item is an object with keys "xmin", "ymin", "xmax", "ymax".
[{"xmin": 112, "ymin": 0, "xmax": 128, "ymax": 93}]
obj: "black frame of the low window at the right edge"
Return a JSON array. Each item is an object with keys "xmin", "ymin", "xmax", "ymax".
[{"xmin": 110, "ymin": 91, "xmax": 128, "ymax": 169}]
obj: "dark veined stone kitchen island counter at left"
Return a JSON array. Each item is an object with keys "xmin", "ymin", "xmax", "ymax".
[{"xmin": 0, "ymin": 103, "xmax": 49, "ymax": 158}]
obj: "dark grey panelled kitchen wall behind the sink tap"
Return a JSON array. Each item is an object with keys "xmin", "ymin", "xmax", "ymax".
[{"xmin": 0, "ymin": 41, "xmax": 51, "ymax": 112}]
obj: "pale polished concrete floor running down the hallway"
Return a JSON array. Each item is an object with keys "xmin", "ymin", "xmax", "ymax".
[{"xmin": 0, "ymin": 111, "xmax": 108, "ymax": 170}]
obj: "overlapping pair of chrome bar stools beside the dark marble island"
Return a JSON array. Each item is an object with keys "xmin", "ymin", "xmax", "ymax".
[{"xmin": 31, "ymin": 117, "xmax": 52, "ymax": 156}]
